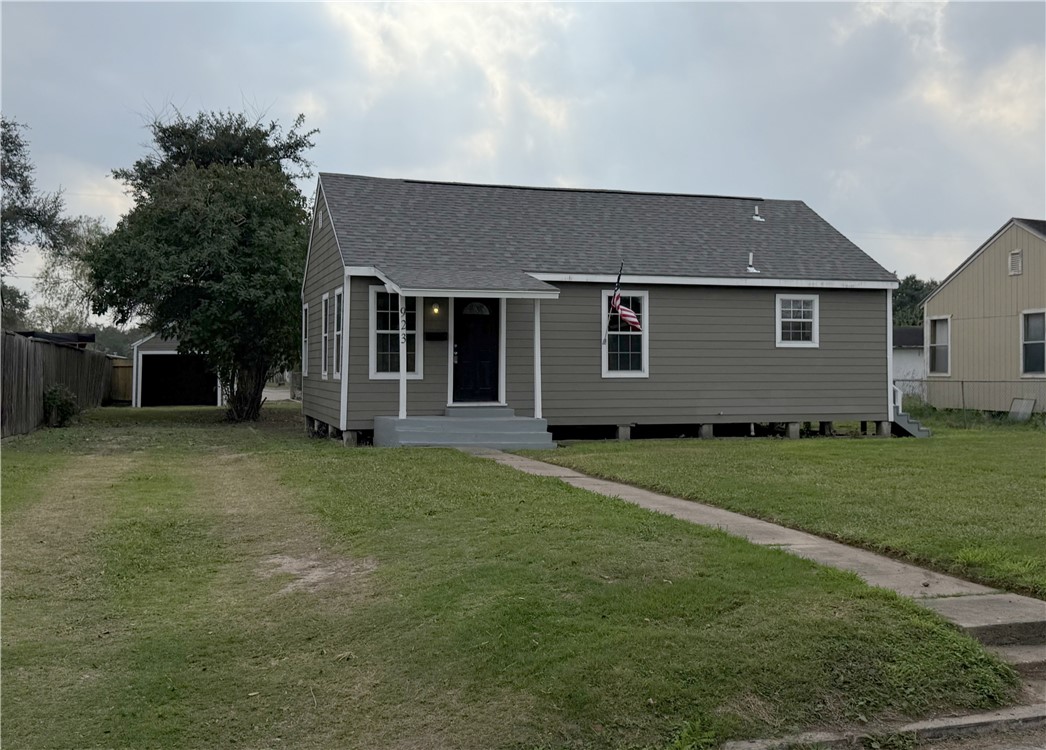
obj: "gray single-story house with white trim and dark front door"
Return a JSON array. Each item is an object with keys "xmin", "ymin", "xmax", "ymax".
[{"xmin": 302, "ymin": 173, "xmax": 897, "ymax": 446}]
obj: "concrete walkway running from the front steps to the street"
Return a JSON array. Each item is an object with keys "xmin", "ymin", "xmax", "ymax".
[{"xmin": 462, "ymin": 448, "xmax": 1046, "ymax": 694}]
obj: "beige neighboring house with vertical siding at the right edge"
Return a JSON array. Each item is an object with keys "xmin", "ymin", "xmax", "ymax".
[{"xmin": 923, "ymin": 219, "xmax": 1046, "ymax": 411}]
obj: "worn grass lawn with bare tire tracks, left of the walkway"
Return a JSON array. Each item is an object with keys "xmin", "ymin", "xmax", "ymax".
[{"xmin": 2, "ymin": 406, "xmax": 1017, "ymax": 749}]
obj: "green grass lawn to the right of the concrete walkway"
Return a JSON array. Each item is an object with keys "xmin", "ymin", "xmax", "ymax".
[{"xmin": 528, "ymin": 423, "xmax": 1046, "ymax": 598}]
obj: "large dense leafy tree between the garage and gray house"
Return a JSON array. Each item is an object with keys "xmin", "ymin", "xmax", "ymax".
[{"xmin": 87, "ymin": 113, "xmax": 316, "ymax": 422}]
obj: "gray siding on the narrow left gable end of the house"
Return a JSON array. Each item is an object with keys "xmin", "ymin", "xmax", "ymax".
[{"xmin": 301, "ymin": 191, "xmax": 344, "ymax": 427}]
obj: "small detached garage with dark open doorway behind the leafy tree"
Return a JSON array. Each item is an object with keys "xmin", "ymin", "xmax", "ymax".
[{"xmin": 131, "ymin": 334, "xmax": 224, "ymax": 407}]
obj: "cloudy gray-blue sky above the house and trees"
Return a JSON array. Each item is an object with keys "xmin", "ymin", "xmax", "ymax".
[{"xmin": 0, "ymin": 1, "xmax": 1046, "ymax": 301}]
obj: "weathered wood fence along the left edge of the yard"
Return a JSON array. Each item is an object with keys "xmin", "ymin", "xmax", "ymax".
[{"xmin": 0, "ymin": 331, "xmax": 113, "ymax": 437}]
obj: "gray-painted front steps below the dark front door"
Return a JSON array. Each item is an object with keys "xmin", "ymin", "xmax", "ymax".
[{"xmin": 374, "ymin": 406, "xmax": 555, "ymax": 450}]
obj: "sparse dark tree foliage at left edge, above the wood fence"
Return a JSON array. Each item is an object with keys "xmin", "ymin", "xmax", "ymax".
[{"xmin": 0, "ymin": 116, "xmax": 68, "ymax": 271}]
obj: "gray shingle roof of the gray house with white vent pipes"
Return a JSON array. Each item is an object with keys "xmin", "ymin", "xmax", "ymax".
[{"xmin": 319, "ymin": 173, "xmax": 896, "ymax": 291}]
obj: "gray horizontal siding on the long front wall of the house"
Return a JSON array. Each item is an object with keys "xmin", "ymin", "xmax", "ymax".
[{"xmin": 338, "ymin": 278, "xmax": 888, "ymax": 429}]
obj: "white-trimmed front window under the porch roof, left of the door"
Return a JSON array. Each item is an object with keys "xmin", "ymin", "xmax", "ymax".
[{"xmin": 370, "ymin": 286, "xmax": 425, "ymax": 380}]
